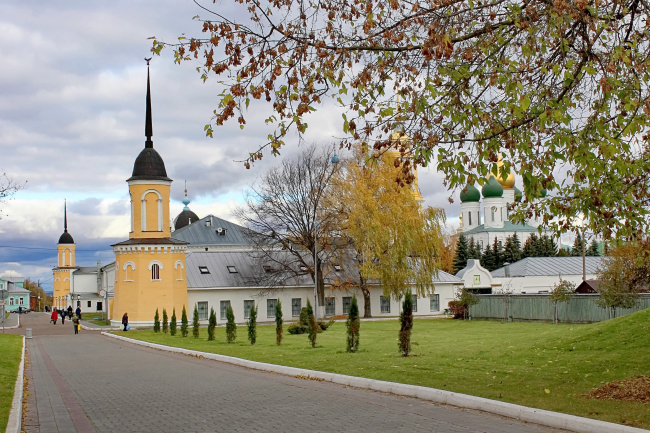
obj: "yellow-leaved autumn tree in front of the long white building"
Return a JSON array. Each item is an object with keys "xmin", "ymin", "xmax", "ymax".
[{"xmin": 327, "ymin": 146, "xmax": 445, "ymax": 317}]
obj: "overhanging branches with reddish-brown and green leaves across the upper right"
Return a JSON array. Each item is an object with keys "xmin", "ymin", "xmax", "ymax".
[{"xmin": 152, "ymin": 0, "xmax": 650, "ymax": 237}]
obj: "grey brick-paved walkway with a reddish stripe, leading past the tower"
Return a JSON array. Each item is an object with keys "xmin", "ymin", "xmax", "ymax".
[{"xmin": 8, "ymin": 313, "xmax": 557, "ymax": 433}]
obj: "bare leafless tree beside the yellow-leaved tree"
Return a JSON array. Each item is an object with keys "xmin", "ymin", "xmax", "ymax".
[{"xmin": 235, "ymin": 145, "xmax": 337, "ymax": 314}]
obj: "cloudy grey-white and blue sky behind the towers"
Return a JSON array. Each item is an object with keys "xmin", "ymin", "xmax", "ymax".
[{"xmin": 0, "ymin": 0, "xmax": 460, "ymax": 291}]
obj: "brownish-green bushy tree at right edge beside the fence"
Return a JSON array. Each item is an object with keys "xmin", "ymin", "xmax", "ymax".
[{"xmin": 596, "ymin": 239, "xmax": 650, "ymax": 317}]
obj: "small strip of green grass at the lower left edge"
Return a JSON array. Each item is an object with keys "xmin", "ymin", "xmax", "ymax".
[{"xmin": 0, "ymin": 334, "xmax": 23, "ymax": 432}]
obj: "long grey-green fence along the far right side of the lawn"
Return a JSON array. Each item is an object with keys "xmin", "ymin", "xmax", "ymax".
[{"xmin": 469, "ymin": 294, "xmax": 650, "ymax": 323}]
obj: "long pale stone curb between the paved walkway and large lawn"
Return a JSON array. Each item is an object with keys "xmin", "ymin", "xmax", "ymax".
[{"xmin": 102, "ymin": 332, "xmax": 649, "ymax": 433}]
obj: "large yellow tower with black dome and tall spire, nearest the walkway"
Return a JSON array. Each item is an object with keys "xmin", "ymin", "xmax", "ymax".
[{"xmin": 111, "ymin": 65, "xmax": 189, "ymax": 325}]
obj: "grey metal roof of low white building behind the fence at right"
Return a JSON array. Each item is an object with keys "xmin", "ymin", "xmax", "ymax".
[{"xmin": 492, "ymin": 257, "xmax": 604, "ymax": 278}]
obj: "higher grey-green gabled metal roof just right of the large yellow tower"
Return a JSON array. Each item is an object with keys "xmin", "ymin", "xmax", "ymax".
[{"xmin": 172, "ymin": 215, "xmax": 250, "ymax": 246}]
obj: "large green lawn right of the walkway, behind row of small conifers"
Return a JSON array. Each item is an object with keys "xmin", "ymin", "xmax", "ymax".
[{"xmin": 123, "ymin": 309, "xmax": 650, "ymax": 429}]
